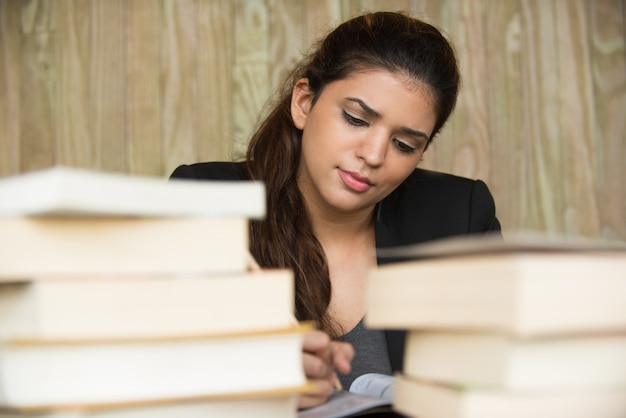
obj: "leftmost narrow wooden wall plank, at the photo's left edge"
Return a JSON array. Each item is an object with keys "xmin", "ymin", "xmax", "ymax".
[{"xmin": 0, "ymin": 1, "xmax": 21, "ymax": 176}]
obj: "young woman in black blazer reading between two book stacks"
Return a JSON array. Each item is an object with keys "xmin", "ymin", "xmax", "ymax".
[{"xmin": 172, "ymin": 12, "xmax": 500, "ymax": 407}]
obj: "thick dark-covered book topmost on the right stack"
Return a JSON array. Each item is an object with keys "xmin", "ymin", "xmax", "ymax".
[{"xmin": 365, "ymin": 238, "xmax": 626, "ymax": 337}]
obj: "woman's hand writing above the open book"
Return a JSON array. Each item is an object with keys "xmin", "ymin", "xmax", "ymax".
[{"xmin": 298, "ymin": 331, "xmax": 354, "ymax": 409}]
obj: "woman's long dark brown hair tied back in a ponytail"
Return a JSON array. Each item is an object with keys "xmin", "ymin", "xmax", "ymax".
[{"xmin": 246, "ymin": 12, "xmax": 459, "ymax": 337}]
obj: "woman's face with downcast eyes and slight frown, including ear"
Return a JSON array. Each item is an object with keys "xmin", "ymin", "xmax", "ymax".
[{"xmin": 291, "ymin": 70, "xmax": 436, "ymax": 214}]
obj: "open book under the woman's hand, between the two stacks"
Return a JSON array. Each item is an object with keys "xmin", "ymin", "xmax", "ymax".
[{"xmin": 298, "ymin": 373, "xmax": 394, "ymax": 418}]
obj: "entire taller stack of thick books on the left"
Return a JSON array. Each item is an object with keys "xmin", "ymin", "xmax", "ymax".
[{"xmin": 0, "ymin": 167, "xmax": 309, "ymax": 418}]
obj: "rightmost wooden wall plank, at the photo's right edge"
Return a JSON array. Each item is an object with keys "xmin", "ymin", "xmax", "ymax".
[{"xmin": 584, "ymin": 0, "xmax": 626, "ymax": 242}]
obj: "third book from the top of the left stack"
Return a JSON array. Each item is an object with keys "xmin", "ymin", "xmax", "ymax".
[{"xmin": 0, "ymin": 269, "xmax": 295, "ymax": 342}]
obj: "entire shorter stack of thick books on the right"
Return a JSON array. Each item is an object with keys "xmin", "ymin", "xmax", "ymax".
[{"xmin": 366, "ymin": 233, "xmax": 626, "ymax": 418}]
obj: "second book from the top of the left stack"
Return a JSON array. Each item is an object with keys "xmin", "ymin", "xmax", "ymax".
[{"xmin": 0, "ymin": 216, "xmax": 250, "ymax": 282}]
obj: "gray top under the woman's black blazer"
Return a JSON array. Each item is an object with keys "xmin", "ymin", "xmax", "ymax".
[{"xmin": 339, "ymin": 319, "xmax": 392, "ymax": 390}]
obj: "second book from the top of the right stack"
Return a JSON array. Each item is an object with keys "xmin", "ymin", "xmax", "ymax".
[{"xmin": 403, "ymin": 331, "xmax": 626, "ymax": 391}]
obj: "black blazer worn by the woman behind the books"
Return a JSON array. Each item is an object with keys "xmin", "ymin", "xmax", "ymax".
[{"xmin": 170, "ymin": 162, "xmax": 500, "ymax": 371}]
